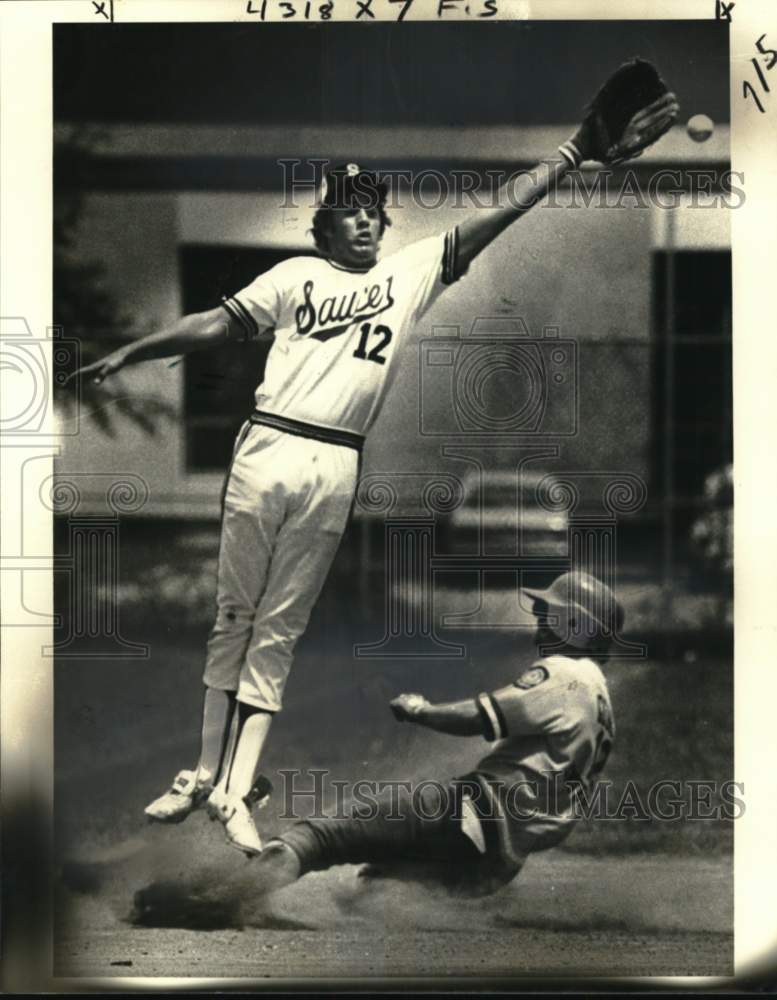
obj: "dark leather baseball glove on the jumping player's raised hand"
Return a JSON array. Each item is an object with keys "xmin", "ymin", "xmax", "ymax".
[{"xmin": 580, "ymin": 59, "xmax": 680, "ymax": 163}]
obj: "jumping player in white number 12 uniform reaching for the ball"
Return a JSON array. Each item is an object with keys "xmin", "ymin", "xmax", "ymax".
[{"xmin": 71, "ymin": 60, "xmax": 678, "ymax": 855}]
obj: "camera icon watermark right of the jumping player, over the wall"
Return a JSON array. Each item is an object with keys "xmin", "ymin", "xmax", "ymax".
[{"xmin": 419, "ymin": 316, "xmax": 578, "ymax": 438}]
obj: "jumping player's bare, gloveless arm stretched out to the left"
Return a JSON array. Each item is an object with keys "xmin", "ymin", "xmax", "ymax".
[{"xmin": 70, "ymin": 306, "xmax": 242, "ymax": 385}]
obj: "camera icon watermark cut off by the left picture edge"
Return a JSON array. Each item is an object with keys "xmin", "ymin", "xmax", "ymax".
[{"xmin": 0, "ymin": 316, "xmax": 80, "ymax": 435}]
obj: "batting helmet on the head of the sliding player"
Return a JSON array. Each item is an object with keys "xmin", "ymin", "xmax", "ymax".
[{"xmin": 523, "ymin": 570, "xmax": 624, "ymax": 649}]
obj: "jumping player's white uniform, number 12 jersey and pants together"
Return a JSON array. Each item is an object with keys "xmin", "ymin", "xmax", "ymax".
[{"xmin": 204, "ymin": 228, "xmax": 460, "ymax": 711}]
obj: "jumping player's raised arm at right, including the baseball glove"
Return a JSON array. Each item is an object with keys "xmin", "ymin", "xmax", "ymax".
[{"xmin": 457, "ymin": 59, "xmax": 679, "ymax": 273}]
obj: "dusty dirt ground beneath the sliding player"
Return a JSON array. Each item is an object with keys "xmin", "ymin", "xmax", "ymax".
[{"xmin": 55, "ymin": 844, "xmax": 733, "ymax": 982}]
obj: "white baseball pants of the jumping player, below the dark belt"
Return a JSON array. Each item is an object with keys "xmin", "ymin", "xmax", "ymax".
[{"xmin": 203, "ymin": 423, "xmax": 359, "ymax": 712}]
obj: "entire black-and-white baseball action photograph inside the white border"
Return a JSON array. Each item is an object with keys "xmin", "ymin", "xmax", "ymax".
[{"xmin": 2, "ymin": 0, "xmax": 777, "ymax": 989}]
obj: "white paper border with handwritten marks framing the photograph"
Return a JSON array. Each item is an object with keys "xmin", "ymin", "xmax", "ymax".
[{"xmin": 0, "ymin": 0, "xmax": 777, "ymax": 992}]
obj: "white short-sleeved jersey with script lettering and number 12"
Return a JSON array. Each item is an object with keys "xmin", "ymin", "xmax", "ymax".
[{"xmin": 224, "ymin": 229, "xmax": 459, "ymax": 437}]
